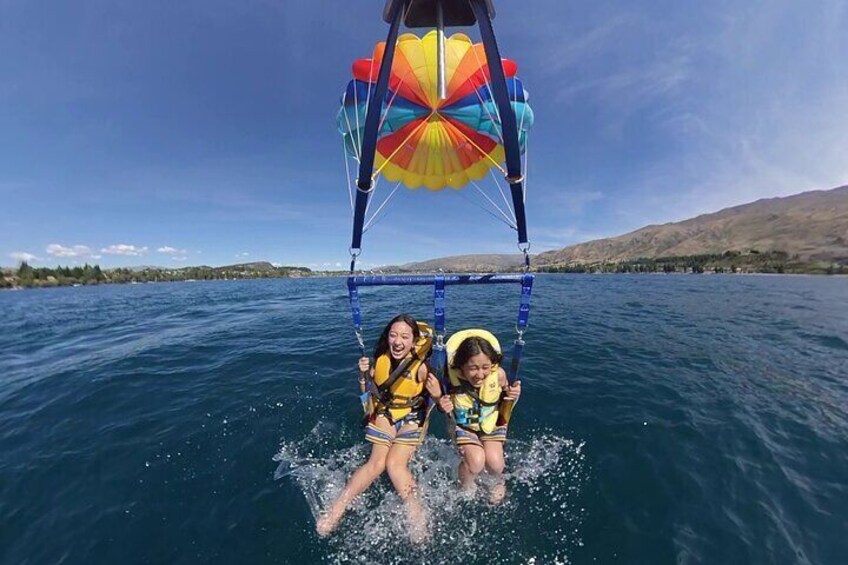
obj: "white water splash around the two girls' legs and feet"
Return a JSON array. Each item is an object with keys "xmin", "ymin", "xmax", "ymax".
[{"xmin": 274, "ymin": 423, "xmax": 587, "ymax": 564}]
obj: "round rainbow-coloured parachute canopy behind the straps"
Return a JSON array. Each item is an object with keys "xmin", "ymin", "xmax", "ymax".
[{"xmin": 338, "ymin": 31, "xmax": 533, "ymax": 190}]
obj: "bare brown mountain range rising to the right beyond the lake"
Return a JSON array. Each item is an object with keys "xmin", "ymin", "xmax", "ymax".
[{"xmin": 396, "ymin": 185, "xmax": 848, "ymax": 272}]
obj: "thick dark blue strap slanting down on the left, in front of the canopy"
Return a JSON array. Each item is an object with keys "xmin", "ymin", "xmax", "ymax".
[{"xmin": 350, "ymin": 0, "xmax": 409, "ymax": 250}]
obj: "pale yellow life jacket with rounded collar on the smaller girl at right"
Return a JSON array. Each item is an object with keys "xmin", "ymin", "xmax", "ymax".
[{"xmin": 445, "ymin": 329, "xmax": 502, "ymax": 433}]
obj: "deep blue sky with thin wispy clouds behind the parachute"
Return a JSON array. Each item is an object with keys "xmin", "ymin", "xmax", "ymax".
[{"xmin": 0, "ymin": 0, "xmax": 848, "ymax": 269}]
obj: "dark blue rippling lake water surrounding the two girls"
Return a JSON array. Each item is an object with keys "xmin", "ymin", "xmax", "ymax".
[{"xmin": 0, "ymin": 275, "xmax": 848, "ymax": 565}]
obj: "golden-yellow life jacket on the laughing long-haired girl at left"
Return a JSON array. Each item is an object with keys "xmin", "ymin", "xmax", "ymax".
[{"xmin": 365, "ymin": 322, "xmax": 433, "ymax": 423}]
